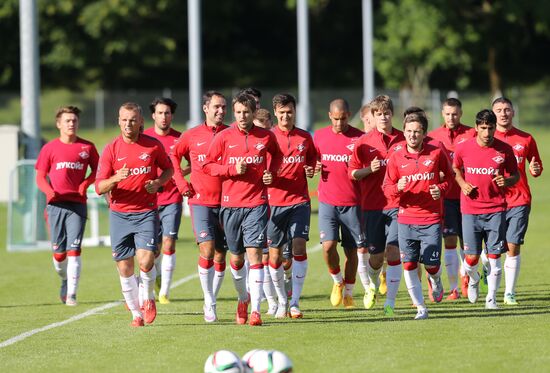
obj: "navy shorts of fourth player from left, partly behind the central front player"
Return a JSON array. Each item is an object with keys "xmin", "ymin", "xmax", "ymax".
[{"xmin": 189, "ymin": 205, "xmax": 227, "ymax": 250}]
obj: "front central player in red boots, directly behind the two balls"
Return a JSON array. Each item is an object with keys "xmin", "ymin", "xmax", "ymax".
[{"xmin": 202, "ymin": 94, "xmax": 280, "ymax": 325}]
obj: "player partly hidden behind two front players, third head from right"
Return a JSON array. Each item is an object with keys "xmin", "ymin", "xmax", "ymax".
[{"xmin": 428, "ymin": 98, "xmax": 476, "ymax": 300}]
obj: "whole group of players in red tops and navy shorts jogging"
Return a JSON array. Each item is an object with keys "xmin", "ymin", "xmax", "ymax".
[{"xmin": 36, "ymin": 89, "xmax": 542, "ymax": 326}]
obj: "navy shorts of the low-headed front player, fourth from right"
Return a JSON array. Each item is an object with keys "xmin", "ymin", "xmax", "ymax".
[{"xmin": 398, "ymin": 224, "xmax": 441, "ymax": 266}]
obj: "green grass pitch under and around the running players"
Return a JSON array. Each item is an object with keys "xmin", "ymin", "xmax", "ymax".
[{"xmin": 0, "ymin": 129, "xmax": 550, "ymax": 372}]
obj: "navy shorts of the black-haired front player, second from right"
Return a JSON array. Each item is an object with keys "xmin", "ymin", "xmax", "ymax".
[{"xmin": 462, "ymin": 211, "xmax": 506, "ymax": 255}]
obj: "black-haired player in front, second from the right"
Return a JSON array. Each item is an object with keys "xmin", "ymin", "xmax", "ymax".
[{"xmin": 453, "ymin": 110, "xmax": 519, "ymax": 309}]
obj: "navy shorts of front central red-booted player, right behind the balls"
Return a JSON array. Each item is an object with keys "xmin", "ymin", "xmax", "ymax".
[{"xmin": 220, "ymin": 205, "xmax": 267, "ymax": 255}]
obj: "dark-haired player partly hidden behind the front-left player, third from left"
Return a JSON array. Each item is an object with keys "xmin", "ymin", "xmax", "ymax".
[{"xmin": 143, "ymin": 97, "xmax": 183, "ymax": 304}]
